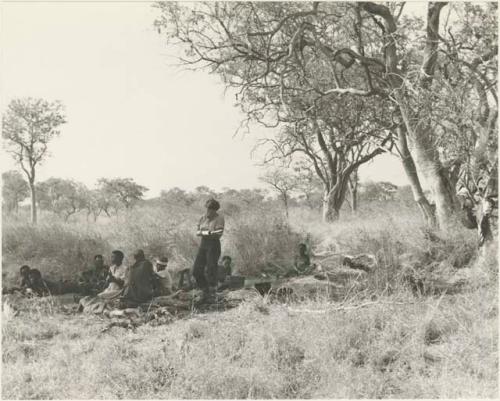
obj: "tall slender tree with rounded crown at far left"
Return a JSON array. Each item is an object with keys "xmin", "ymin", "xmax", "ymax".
[{"xmin": 2, "ymin": 98, "xmax": 66, "ymax": 224}]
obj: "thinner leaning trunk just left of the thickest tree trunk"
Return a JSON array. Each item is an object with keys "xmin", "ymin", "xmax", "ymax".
[{"xmin": 397, "ymin": 125, "xmax": 436, "ymax": 226}]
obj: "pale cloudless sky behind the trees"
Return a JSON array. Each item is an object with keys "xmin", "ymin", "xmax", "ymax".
[{"xmin": 0, "ymin": 2, "xmax": 414, "ymax": 197}]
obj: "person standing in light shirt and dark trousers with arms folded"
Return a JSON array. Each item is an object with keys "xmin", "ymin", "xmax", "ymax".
[{"xmin": 193, "ymin": 198, "xmax": 224, "ymax": 302}]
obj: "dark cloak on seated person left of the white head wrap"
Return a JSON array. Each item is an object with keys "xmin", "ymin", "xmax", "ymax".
[{"xmin": 123, "ymin": 260, "xmax": 154, "ymax": 304}]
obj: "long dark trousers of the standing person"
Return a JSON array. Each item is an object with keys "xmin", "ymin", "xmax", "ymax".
[{"xmin": 193, "ymin": 237, "xmax": 221, "ymax": 290}]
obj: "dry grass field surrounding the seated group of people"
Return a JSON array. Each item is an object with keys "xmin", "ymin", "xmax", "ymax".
[{"xmin": 2, "ymin": 202, "xmax": 498, "ymax": 399}]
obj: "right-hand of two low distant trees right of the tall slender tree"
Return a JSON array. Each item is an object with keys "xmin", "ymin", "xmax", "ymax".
[{"xmin": 98, "ymin": 178, "xmax": 148, "ymax": 210}]
